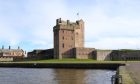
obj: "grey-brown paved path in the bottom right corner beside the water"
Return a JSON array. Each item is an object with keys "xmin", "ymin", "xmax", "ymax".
[{"xmin": 126, "ymin": 62, "xmax": 140, "ymax": 84}]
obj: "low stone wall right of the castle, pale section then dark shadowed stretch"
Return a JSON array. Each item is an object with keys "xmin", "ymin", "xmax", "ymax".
[{"xmin": 95, "ymin": 50, "xmax": 140, "ymax": 60}]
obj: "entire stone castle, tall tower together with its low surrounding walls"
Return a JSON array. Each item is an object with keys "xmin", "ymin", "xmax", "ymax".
[{"xmin": 28, "ymin": 18, "xmax": 140, "ymax": 60}]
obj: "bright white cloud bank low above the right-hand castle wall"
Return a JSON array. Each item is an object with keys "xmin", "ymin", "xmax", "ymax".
[{"xmin": 86, "ymin": 38, "xmax": 140, "ymax": 49}]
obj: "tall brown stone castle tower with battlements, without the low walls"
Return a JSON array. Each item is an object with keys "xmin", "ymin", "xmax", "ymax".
[{"xmin": 53, "ymin": 18, "xmax": 84, "ymax": 59}]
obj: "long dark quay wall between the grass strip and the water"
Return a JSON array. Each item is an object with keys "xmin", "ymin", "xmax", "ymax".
[{"xmin": 0, "ymin": 62, "xmax": 125, "ymax": 70}]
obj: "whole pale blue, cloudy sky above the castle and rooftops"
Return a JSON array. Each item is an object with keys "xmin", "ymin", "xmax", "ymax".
[{"xmin": 0, "ymin": 0, "xmax": 140, "ymax": 51}]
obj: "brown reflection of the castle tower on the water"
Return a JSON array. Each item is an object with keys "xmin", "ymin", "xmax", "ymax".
[{"xmin": 55, "ymin": 69, "xmax": 85, "ymax": 84}]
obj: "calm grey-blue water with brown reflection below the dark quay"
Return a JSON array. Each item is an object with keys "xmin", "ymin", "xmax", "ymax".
[{"xmin": 0, "ymin": 68, "xmax": 115, "ymax": 84}]
